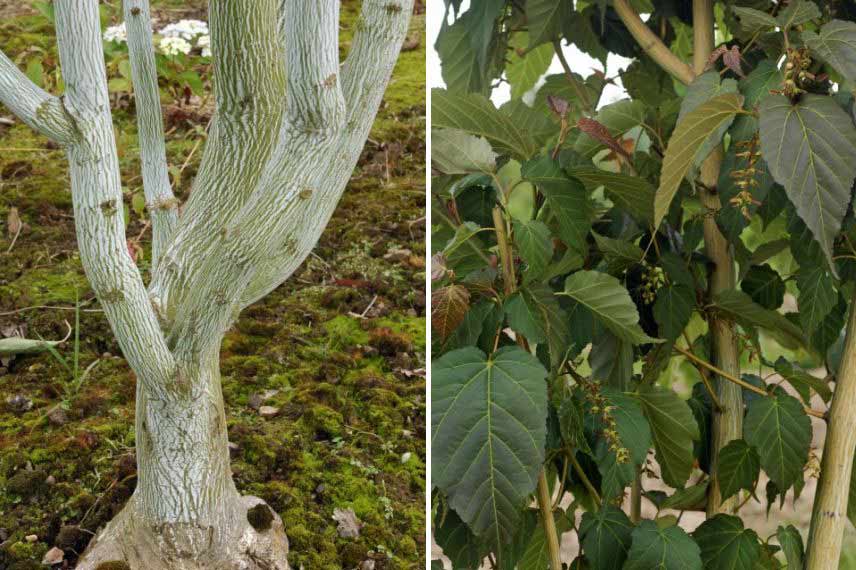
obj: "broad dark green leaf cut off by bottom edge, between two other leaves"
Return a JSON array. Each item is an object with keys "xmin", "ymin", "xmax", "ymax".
[{"xmin": 622, "ymin": 520, "xmax": 702, "ymax": 570}]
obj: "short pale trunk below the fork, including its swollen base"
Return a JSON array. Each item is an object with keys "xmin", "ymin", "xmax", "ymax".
[{"xmin": 77, "ymin": 356, "xmax": 288, "ymax": 570}]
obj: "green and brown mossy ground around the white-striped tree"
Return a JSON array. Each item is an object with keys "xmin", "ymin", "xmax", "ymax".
[{"xmin": 0, "ymin": 0, "xmax": 425, "ymax": 570}]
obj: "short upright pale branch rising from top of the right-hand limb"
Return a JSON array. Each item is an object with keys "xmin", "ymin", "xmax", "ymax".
[{"xmin": 281, "ymin": 0, "xmax": 345, "ymax": 131}]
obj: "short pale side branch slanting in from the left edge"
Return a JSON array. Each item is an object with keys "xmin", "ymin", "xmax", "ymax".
[{"xmin": 0, "ymin": 48, "xmax": 77, "ymax": 146}]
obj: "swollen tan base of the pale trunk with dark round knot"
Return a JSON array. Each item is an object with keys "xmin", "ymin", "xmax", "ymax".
[{"xmin": 76, "ymin": 495, "xmax": 289, "ymax": 570}]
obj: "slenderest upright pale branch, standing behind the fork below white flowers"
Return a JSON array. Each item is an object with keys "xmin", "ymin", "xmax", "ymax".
[{"xmin": 123, "ymin": 0, "xmax": 178, "ymax": 271}]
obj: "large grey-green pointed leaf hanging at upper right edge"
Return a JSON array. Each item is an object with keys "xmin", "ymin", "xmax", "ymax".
[{"xmin": 760, "ymin": 94, "xmax": 856, "ymax": 268}]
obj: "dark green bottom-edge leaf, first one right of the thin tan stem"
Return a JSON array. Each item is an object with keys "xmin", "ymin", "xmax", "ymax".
[{"xmin": 580, "ymin": 505, "xmax": 633, "ymax": 570}]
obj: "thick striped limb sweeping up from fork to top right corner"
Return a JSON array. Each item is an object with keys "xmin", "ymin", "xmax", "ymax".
[{"xmin": 167, "ymin": 0, "xmax": 413, "ymax": 352}]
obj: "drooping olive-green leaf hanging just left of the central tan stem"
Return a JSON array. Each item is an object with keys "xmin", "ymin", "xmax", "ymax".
[{"xmin": 638, "ymin": 386, "xmax": 699, "ymax": 489}]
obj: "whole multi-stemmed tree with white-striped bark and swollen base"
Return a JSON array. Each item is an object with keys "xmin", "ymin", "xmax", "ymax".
[{"xmin": 0, "ymin": 0, "xmax": 412, "ymax": 570}]
